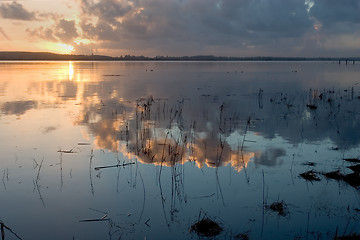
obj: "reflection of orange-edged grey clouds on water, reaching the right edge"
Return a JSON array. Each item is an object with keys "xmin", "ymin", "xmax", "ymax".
[{"xmin": 72, "ymin": 87, "xmax": 360, "ymax": 171}]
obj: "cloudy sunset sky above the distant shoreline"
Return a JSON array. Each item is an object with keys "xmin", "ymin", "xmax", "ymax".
[{"xmin": 0, "ymin": 0, "xmax": 360, "ymax": 57}]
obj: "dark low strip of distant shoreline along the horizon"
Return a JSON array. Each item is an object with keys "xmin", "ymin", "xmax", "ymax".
[{"xmin": 0, "ymin": 51, "xmax": 360, "ymax": 64}]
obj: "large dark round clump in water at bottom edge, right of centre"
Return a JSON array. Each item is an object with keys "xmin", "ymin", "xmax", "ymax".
[{"xmin": 190, "ymin": 218, "xmax": 223, "ymax": 237}]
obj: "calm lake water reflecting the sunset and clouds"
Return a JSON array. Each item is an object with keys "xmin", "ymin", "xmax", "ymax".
[{"xmin": 0, "ymin": 62, "xmax": 360, "ymax": 239}]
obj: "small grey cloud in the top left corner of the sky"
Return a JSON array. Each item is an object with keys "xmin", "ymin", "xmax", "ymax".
[{"xmin": 0, "ymin": 2, "xmax": 36, "ymax": 21}]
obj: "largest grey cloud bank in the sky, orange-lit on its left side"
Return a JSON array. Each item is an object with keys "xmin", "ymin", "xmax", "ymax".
[{"xmin": 74, "ymin": 0, "xmax": 313, "ymax": 55}]
